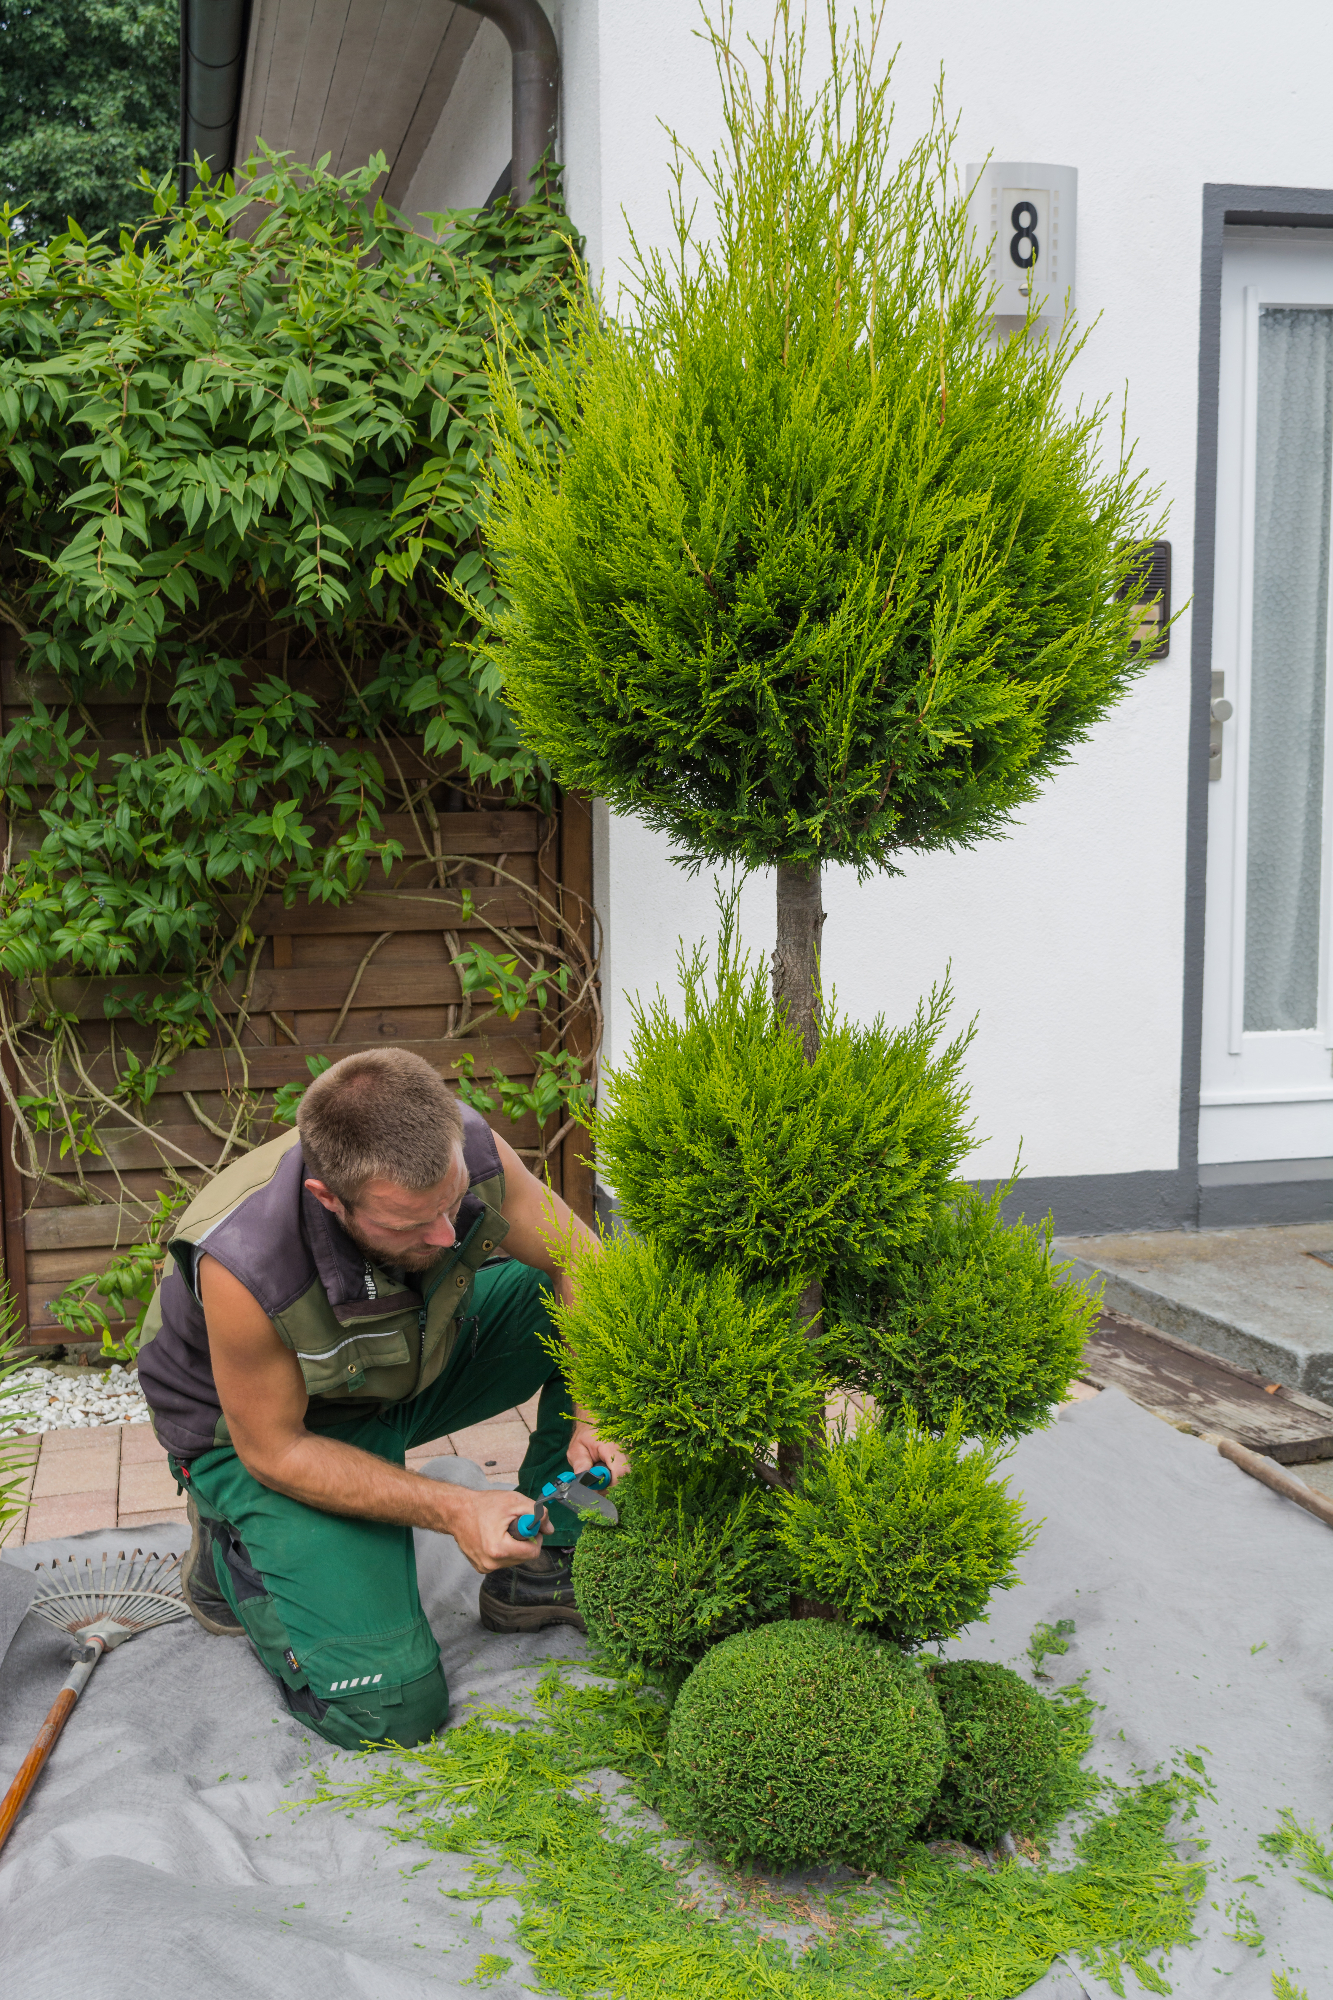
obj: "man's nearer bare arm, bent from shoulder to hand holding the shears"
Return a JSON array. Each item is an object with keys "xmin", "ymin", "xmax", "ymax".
[{"xmin": 198, "ymin": 1256, "xmax": 540, "ymax": 1574}]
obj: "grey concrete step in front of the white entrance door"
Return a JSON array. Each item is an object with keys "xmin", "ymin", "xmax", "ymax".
[{"xmin": 1055, "ymin": 1220, "xmax": 1333, "ymax": 1402}]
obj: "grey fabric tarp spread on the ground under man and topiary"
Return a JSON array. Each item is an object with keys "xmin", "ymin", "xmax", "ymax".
[{"xmin": 0, "ymin": 1390, "xmax": 1333, "ymax": 2000}]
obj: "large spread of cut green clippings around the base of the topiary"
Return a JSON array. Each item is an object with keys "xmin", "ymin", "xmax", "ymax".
[{"xmin": 304, "ymin": 1666, "xmax": 1200, "ymax": 2000}]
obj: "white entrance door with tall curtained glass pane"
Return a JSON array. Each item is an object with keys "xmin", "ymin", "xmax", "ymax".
[{"xmin": 1199, "ymin": 230, "xmax": 1333, "ymax": 1162}]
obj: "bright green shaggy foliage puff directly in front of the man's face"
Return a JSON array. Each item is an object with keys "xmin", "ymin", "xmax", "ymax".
[{"xmin": 548, "ymin": 1236, "xmax": 823, "ymax": 1486}]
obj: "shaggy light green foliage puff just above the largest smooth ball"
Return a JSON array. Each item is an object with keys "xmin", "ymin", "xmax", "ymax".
[{"xmin": 779, "ymin": 1410, "xmax": 1037, "ymax": 1648}]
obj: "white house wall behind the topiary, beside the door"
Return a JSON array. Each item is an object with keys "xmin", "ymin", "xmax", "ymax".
[{"xmin": 552, "ymin": 0, "xmax": 1333, "ymax": 1200}]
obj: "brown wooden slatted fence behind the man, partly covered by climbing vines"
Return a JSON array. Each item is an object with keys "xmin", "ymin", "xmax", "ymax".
[{"xmin": 0, "ymin": 642, "xmax": 600, "ymax": 1344}]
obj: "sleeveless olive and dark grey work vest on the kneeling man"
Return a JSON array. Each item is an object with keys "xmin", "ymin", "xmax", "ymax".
[{"xmin": 138, "ymin": 1104, "xmax": 508, "ymax": 1460}]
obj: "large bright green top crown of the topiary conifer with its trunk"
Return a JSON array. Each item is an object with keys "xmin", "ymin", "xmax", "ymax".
[{"xmin": 488, "ymin": 0, "xmax": 1151, "ymax": 1360}]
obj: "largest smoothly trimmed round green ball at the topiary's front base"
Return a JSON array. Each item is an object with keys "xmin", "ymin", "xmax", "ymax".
[{"xmin": 667, "ymin": 1618, "xmax": 945, "ymax": 1868}]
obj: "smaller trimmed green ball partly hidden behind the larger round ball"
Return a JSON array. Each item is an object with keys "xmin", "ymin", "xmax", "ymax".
[{"xmin": 923, "ymin": 1660, "xmax": 1059, "ymax": 1848}]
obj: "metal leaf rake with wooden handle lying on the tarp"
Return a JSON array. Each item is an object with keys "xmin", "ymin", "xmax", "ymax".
[{"xmin": 0, "ymin": 1548, "xmax": 190, "ymax": 1848}]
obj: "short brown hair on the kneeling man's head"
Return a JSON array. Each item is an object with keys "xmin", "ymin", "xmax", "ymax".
[{"xmin": 296, "ymin": 1048, "xmax": 462, "ymax": 1208}]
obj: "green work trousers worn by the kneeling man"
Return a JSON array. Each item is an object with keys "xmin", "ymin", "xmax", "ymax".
[{"xmin": 172, "ymin": 1262, "xmax": 578, "ymax": 1748}]
